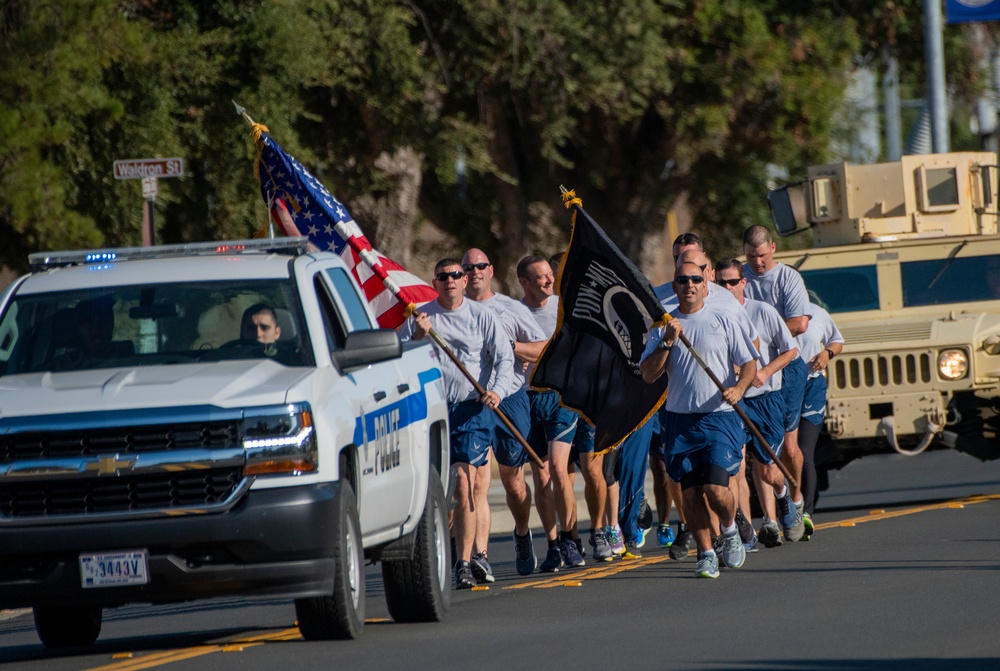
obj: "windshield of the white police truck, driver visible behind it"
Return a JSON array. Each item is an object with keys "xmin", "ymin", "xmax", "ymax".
[{"xmin": 0, "ymin": 280, "xmax": 314, "ymax": 375}]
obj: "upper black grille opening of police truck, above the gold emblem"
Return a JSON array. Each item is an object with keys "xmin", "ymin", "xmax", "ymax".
[{"xmin": 0, "ymin": 420, "xmax": 239, "ymax": 462}]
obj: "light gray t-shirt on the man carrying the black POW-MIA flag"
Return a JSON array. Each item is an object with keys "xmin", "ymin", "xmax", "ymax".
[{"xmin": 646, "ymin": 305, "xmax": 757, "ymax": 413}]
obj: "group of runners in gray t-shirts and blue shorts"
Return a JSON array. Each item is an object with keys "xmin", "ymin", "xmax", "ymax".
[{"xmin": 401, "ymin": 226, "xmax": 843, "ymax": 589}]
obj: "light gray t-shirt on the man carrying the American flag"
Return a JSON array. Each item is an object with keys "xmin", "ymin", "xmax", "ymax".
[{"xmin": 399, "ymin": 299, "xmax": 519, "ymax": 403}]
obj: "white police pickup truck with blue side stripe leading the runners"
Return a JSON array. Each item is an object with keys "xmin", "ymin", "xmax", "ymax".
[{"xmin": 0, "ymin": 238, "xmax": 450, "ymax": 647}]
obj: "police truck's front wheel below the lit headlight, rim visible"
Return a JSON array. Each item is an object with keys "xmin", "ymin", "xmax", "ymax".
[{"xmin": 295, "ymin": 481, "xmax": 365, "ymax": 641}]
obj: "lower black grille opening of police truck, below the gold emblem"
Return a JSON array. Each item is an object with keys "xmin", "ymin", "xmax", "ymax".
[{"xmin": 0, "ymin": 467, "xmax": 242, "ymax": 519}]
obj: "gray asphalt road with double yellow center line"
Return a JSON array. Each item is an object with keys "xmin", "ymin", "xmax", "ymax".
[{"xmin": 0, "ymin": 452, "xmax": 1000, "ymax": 671}]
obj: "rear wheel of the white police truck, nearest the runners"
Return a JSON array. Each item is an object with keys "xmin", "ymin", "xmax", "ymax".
[{"xmin": 382, "ymin": 466, "xmax": 451, "ymax": 622}]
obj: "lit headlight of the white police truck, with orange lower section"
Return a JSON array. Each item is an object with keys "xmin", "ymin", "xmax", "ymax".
[{"xmin": 243, "ymin": 403, "xmax": 319, "ymax": 475}]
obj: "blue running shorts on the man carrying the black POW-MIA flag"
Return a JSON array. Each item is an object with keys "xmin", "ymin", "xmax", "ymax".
[{"xmin": 665, "ymin": 411, "xmax": 746, "ymax": 482}]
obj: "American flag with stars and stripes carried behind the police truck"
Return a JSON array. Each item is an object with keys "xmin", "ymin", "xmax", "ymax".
[{"xmin": 252, "ymin": 124, "xmax": 437, "ymax": 328}]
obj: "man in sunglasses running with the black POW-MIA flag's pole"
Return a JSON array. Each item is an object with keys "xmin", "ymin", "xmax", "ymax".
[{"xmin": 640, "ymin": 263, "xmax": 757, "ymax": 578}]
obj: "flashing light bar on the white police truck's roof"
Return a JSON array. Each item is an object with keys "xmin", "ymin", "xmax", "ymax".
[{"xmin": 28, "ymin": 236, "xmax": 309, "ymax": 272}]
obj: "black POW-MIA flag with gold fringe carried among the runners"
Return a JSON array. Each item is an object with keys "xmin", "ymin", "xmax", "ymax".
[{"xmin": 531, "ymin": 191, "xmax": 667, "ymax": 452}]
